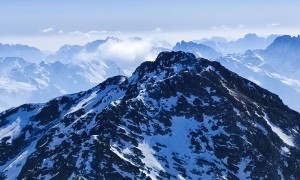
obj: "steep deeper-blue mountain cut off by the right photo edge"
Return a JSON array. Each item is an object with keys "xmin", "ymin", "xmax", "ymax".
[{"xmin": 260, "ymin": 35, "xmax": 300, "ymax": 80}]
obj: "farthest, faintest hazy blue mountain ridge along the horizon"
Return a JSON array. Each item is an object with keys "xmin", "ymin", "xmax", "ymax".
[{"xmin": 0, "ymin": 34, "xmax": 279, "ymax": 63}]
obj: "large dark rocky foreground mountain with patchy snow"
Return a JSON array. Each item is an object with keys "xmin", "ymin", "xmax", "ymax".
[{"xmin": 0, "ymin": 52, "xmax": 300, "ymax": 179}]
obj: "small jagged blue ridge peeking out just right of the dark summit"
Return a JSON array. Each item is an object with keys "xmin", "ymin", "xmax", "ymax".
[{"xmin": 173, "ymin": 41, "xmax": 222, "ymax": 60}]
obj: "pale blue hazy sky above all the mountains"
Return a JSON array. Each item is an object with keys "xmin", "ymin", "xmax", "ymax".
[{"xmin": 0, "ymin": 0, "xmax": 300, "ymax": 50}]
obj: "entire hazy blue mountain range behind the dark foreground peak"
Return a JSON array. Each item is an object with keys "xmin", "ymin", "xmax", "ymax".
[{"xmin": 0, "ymin": 34, "xmax": 300, "ymax": 111}]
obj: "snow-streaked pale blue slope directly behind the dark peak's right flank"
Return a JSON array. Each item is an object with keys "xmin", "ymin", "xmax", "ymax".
[{"xmin": 217, "ymin": 50, "xmax": 300, "ymax": 112}]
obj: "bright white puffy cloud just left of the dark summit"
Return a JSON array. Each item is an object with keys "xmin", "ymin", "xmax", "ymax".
[{"xmin": 76, "ymin": 38, "xmax": 170, "ymax": 75}]
